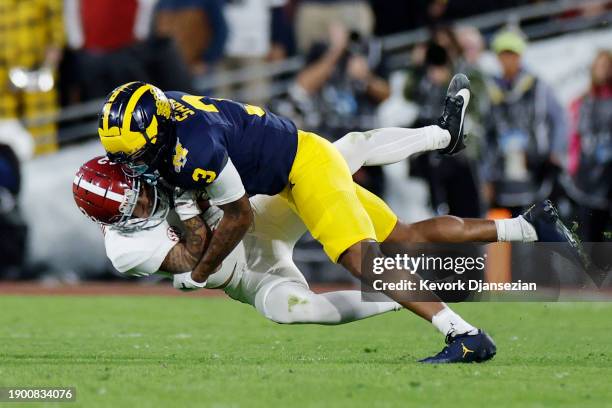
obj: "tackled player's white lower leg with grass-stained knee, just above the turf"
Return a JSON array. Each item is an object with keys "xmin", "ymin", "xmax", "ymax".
[{"xmin": 258, "ymin": 281, "xmax": 401, "ymax": 325}]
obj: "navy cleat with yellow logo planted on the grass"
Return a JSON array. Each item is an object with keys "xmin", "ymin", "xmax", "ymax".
[{"xmin": 419, "ymin": 329, "xmax": 497, "ymax": 364}]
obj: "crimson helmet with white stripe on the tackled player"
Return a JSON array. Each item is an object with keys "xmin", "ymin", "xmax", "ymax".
[{"xmin": 72, "ymin": 156, "xmax": 170, "ymax": 231}]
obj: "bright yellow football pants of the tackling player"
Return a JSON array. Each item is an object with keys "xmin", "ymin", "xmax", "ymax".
[{"xmin": 280, "ymin": 131, "xmax": 397, "ymax": 262}]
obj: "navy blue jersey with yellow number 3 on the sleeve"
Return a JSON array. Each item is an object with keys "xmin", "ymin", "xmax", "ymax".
[{"xmin": 163, "ymin": 92, "xmax": 297, "ymax": 195}]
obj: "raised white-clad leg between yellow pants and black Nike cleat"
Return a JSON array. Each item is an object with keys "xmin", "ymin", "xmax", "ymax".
[{"xmin": 334, "ymin": 125, "xmax": 450, "ymax": 173}]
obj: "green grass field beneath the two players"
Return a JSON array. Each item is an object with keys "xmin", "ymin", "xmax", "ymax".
[{"xmin": 0, "ymin": 296, "xmax": 612, "ymax": 407}]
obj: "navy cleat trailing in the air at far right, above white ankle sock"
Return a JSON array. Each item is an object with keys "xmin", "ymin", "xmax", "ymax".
[{"xmin": 522, "ymin": 200, "xmax": 590, "ymax": 269}]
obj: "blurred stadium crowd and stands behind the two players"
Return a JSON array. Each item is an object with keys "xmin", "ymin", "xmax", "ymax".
[{"xmin": 0, "ymin": 0, "xmax": 612, "ymax": 282}]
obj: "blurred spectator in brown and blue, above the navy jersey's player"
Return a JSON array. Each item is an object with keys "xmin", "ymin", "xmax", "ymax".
[{"xmin": 155, "ymin": 0, "xmax": 228, "ymax": 75}]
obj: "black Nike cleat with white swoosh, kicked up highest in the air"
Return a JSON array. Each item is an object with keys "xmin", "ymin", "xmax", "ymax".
[{"xmin": 438, "ymin": 74, "xmax": 470, "ymax": 155}]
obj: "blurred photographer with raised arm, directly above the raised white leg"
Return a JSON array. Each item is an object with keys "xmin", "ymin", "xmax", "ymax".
[{"xmin": 277, "ymin": 24, "xmax": 390, "ymax": 194}]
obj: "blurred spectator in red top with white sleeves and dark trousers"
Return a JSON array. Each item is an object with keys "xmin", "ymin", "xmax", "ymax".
[{"xmin": 64, "ymin": 0, "xmax": 191, "ymax": 103}]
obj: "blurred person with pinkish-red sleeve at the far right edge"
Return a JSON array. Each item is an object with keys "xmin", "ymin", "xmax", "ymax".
[{"xmin": 568, "ymin": 51, "xmax": 612, "ymax": 242}]
